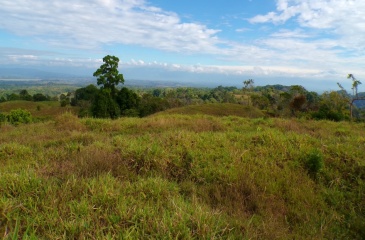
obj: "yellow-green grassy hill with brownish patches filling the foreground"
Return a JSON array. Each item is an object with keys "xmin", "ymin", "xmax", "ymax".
[{"xmin": 0, "ymin": 105, "xmax": 365, "ymax": 239}]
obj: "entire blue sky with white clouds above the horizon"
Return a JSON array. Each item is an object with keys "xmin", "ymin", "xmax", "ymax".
[{"xmin": 0, "ymin": 0, "xmax": 365, "ymax": 91}]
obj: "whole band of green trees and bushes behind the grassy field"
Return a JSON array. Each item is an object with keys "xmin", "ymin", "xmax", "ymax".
[{"xmin": 1, "ymin": 55, "xmax": 365, "ymax": 121}]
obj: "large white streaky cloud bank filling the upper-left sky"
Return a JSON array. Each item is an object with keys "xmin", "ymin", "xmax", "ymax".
[{"xmin": 0, "ymin": 0, "xmax": 219, "ymax": 52}]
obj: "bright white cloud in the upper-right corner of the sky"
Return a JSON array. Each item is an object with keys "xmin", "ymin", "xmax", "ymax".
[{"xmin": 250, "ymin": 0, "xmax": 365, "ymax": 51}]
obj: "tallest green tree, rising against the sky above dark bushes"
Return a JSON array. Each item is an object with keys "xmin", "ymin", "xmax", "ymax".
[{"xmin": 93, "ymin": 55, "xmax": 124, "ymax": 97}]
